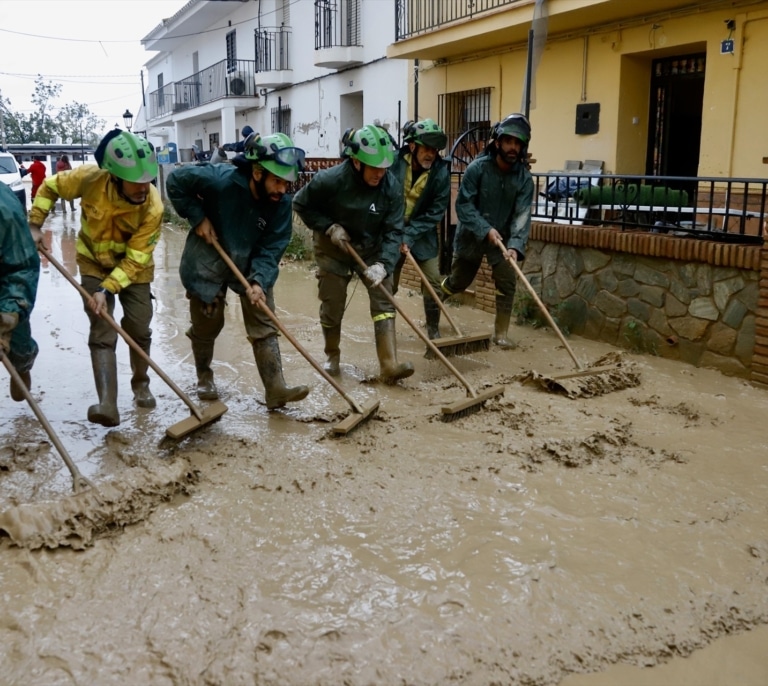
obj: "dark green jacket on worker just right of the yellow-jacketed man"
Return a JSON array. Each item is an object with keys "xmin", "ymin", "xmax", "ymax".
[{"xmin": 166, "ymin": 163, "xmax": 293, "ymax": 303}]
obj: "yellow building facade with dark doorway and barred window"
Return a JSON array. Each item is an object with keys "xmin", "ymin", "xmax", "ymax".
[{"xmin": 388, "ymin": 0, "xmax": 768, "ymax": 178}]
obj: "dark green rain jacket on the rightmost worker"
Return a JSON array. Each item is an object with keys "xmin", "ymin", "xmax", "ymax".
[{"xmin": 453, "ymin": 154, "xmax": 533, "ymax": 266}]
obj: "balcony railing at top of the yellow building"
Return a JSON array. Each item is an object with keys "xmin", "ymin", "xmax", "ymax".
[{"xmin": 395, "ymin": 0, "xmax": 523, "ymax": 41}]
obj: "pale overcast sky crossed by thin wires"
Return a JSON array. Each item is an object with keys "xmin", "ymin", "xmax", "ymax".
[{"xmin": 0, "ymin": 0, "xmax": 186, "ymax": 134}]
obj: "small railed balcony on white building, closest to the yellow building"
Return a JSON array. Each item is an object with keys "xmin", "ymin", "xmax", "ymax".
[{"xmin": 314, "ymin": 0, "xmax": 363, "ymax": 69}]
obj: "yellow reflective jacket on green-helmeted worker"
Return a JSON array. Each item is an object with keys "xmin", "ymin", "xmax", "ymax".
[{"xmin": 29, "ymin": 169, "xmax": 163, "ymax": 293}]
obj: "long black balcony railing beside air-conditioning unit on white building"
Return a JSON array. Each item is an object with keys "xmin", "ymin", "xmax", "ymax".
[{"xmin": 149, "ymin": 60, "xmax": 258, "ymax": 121}]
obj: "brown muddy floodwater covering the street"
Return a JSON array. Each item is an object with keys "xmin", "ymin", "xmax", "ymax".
[{"xmin": 0, "ymin": 214, "xmax": 768, "ymax": 686}]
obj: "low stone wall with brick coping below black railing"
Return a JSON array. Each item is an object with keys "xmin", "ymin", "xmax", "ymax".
[{"xmin": 403, "ymin": 223, "xmax": 768, "ymax": 387}]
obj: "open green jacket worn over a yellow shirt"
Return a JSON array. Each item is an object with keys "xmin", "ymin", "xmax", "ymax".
[{"xmin": 389, "ymin": 145, "xmax": 451, "ymax": 262}]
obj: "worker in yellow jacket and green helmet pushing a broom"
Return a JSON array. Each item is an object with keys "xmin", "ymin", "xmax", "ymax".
[{"xmin": 29, "ymin": 129, "xmax": 163, "ymax": 426}]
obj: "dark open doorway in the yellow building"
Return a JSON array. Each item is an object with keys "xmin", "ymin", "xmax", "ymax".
[{"xmin": 645, "ymin": 53, "xmax": 706, "ymax": 192}]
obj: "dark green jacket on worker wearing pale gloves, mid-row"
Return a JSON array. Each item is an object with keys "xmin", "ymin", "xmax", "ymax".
[{"xmin": 293, "ymin": 160, "xmax": 405, "ymax": 274}]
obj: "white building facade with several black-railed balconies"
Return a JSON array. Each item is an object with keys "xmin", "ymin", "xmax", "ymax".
[{"xmin": 140, "ymin": 0, "xmax": 412, "ymax": 161}]
